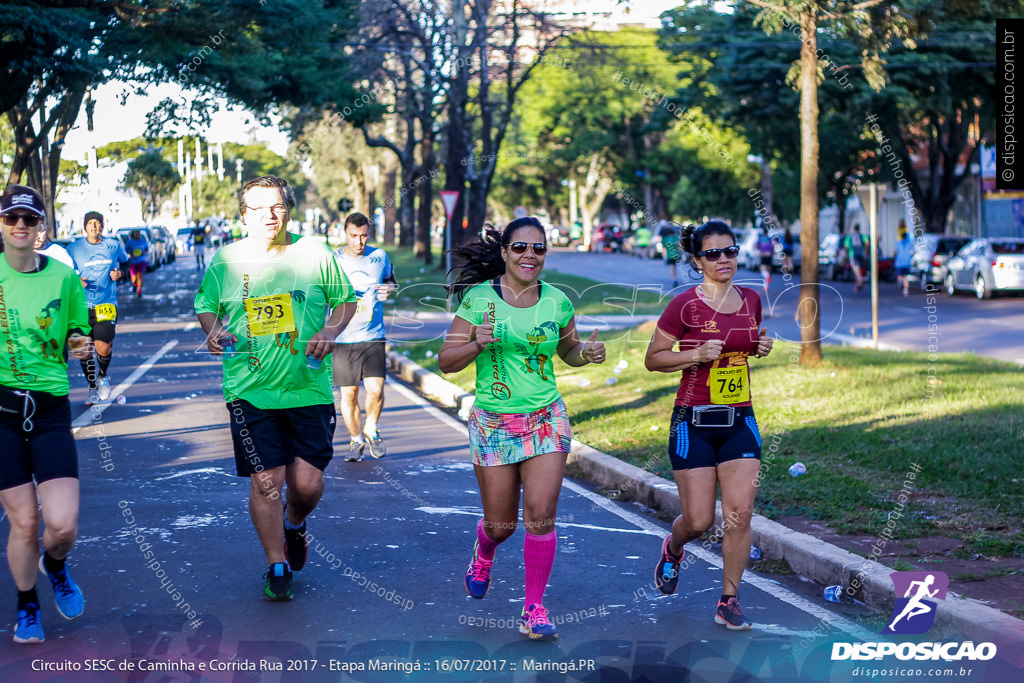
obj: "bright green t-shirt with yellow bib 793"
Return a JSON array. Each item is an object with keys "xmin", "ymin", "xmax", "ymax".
[{"xmin": 196, "ymin": 234, "xmax": 356, "ymax": 409}]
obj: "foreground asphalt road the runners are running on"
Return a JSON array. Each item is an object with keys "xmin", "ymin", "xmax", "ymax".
[{"xmin": 0, "ymin": 261, "xmax": 1019, "ymax": 683}]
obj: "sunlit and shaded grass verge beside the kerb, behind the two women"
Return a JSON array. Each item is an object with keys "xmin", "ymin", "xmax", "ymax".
[{"xmin": 409, "ymin": 326, "xmax": 1024, "ymax": 557}]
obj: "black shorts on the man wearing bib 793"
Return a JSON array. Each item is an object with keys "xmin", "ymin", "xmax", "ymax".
[{"xmin": 227, "ymin": 398, "xmax": 335, "ymax": 477}]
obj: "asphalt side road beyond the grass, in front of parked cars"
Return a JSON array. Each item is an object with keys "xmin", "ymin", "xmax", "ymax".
[{"xmin": 545, "ymin": 249, "xmax": 1024, "ymax": 364}]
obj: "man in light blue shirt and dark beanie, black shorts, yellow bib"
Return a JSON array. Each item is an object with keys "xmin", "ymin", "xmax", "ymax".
[{"xmin": 68, "ymin": 211, "xmax": 128, "ymax": 405}]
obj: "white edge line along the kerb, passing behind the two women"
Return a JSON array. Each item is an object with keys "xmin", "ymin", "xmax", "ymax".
[{"xmin": 387, "ymin": 378, "xmax": 877, "ymax": 640}]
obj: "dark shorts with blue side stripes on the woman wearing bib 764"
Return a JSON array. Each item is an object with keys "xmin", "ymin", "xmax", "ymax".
[{"xmin": 669, "ymin": 405, "xmax": 761, "ymax": 470}]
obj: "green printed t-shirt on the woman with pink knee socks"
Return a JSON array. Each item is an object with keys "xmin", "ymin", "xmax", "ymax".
[{"xmin": 456, "ymin": 282, "xmax": 574, "ymax": 413}]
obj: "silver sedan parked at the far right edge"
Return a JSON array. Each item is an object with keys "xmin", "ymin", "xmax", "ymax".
[{"xmin": 945, "ymin": 238, "xmax": 1024, "ymax": 299}]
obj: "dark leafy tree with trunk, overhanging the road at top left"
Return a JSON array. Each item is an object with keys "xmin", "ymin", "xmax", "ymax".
[{"xmin": 0, "ymin": 0, "xmax": 354, "ymax": 224}]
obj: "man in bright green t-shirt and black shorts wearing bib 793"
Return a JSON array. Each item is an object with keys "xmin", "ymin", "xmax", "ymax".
[{"xmin": 196, "ymin": 176, "xmax": 356, "ymax": 600}]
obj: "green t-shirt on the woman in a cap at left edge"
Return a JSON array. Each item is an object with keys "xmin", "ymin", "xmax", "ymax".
[{"xmin": 0, "ymin": 254, "xmax": 90, "ymax": 396}]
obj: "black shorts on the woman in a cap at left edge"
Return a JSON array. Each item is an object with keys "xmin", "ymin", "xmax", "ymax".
[{"xmin": 0, "ymin": 387, "xmax": 78, "ymax": 490}]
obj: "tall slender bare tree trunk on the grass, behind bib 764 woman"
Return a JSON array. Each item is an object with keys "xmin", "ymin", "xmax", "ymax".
[{"xmin": 794, "ymin": 5, "xmax": 821, "ymax": 366}]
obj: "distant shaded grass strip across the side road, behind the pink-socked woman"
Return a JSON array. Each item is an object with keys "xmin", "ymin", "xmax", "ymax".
[{"xmin": 387, "ymin": 248, "xmax": 667, "ymax": 315}]
